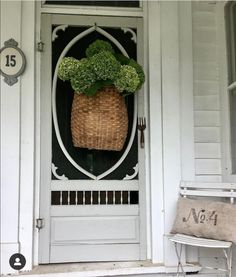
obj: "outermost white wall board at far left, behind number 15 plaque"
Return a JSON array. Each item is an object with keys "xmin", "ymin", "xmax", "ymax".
[{"xmin": 1, "ymin": 1, "xmax": 21, "ymax": 269}]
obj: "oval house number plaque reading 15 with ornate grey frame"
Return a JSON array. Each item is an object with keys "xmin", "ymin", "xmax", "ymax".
[{"xmin": 0, "ymin": 39, "xmax": 26, "ymax": 86}]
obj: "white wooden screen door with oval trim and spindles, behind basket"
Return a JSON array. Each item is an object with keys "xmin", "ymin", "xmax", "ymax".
[{"xmin": 39, "ymin": 14, "xmax": 146, "ymax": 263}]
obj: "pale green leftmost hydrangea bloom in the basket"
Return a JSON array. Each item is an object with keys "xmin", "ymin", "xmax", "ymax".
[{"xmin": 57, "ymin": 57, "xmax": 80, "ymax": 81}]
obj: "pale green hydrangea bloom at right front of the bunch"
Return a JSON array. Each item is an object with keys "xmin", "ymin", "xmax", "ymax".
[{"xmin": 114, "ymin": 65, "xmax": 140, "ymax": 93}]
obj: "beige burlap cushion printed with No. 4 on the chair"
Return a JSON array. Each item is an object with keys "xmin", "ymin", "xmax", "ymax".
[{"xmin": 171, "ymin": 197, "xmax": 236, "ymax": 244}]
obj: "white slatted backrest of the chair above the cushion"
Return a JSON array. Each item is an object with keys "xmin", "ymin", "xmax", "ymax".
[{"xmin": 180, "ymin": 181, "xmax": 236, "ymax": 204}]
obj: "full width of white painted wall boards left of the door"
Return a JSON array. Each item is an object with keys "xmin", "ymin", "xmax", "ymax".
[{"xmin": 0, "ymin": 0, "xmax": 35, "ymax": 273}]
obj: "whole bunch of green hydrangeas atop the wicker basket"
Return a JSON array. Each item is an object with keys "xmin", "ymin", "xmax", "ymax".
[{"xmin": 58, "ymin": 40, "xmax": 145, "ymax": 96}]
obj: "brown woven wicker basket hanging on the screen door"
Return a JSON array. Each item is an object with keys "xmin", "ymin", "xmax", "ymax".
[{"xmin": 71, "ymin": 86, "xmax": 128, "ymax": 151}]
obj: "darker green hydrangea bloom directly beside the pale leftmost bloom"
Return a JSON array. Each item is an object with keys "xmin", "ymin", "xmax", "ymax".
[{"xmin": 71, "ymin": 59, "xmax": 96, "ymax": 92}]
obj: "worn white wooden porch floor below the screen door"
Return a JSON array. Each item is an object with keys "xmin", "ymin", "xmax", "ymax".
[{"xmin": 12, "ymin": 261, "xmax": 219, "ymax": 277}]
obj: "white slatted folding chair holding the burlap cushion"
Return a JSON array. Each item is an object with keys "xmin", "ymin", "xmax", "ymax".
[{"xmin": 169, "ymin": 181, "xmax": 236, "ymax": 277}]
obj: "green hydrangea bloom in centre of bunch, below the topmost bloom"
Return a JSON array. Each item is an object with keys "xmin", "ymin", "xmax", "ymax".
[{"xmin": 90, "ymin": 51, "xmax": 121, "ymax": 80}]
